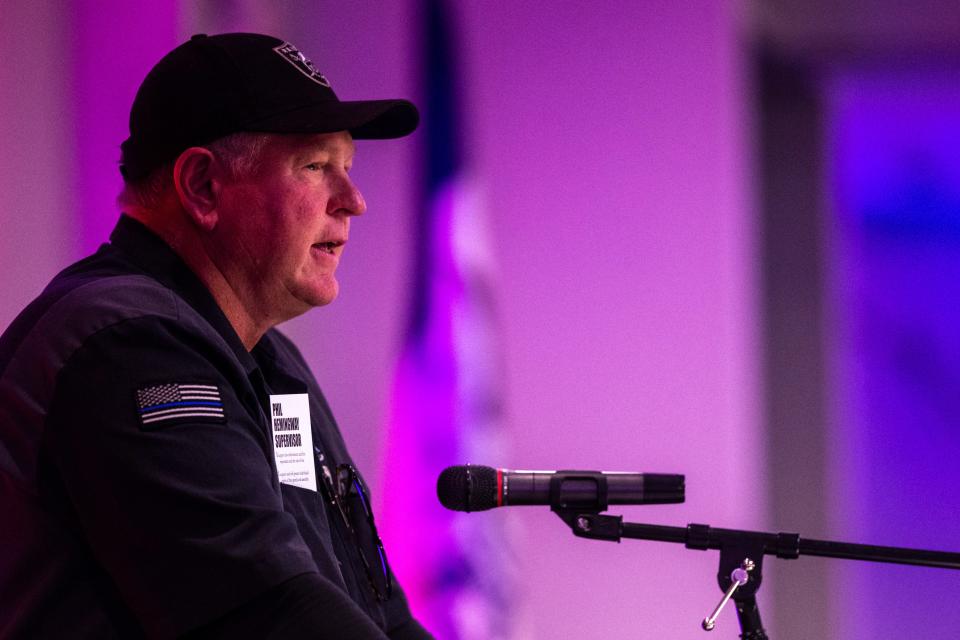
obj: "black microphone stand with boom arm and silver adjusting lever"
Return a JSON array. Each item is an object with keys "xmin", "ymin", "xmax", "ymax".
[{"xmin": 550, "ymin": 477, "xmax": 960, "ymax": 640}]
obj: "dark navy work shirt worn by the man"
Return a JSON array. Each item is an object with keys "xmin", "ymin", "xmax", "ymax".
[{"xmin": 0, "ymin": 217, "xmax": 420, "ymax": 638}]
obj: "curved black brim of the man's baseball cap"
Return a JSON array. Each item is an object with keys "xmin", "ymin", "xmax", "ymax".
[{"xmin": 244, "ymin": 100, "xmax": 420, "ymax": 140}]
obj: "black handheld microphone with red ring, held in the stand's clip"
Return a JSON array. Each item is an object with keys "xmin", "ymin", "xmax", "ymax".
[{"xmin": 437, "ymin": 464, "xmax": 684, "ymax": 511}]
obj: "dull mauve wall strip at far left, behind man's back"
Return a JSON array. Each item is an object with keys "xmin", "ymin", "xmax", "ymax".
[{"xmin": 0, "ymin": 2, "xmax": 76, "ymax": 327}]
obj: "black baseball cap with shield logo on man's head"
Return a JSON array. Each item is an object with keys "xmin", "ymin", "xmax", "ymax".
[{"xmin": 120, "ymin": 33, "xmax": 420, "ymax": 181}]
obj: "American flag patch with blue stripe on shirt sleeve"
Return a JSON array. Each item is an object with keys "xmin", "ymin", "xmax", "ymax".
[{"xmin": 137, "ymin": 383, "xmax": 225, "ymax": 427}]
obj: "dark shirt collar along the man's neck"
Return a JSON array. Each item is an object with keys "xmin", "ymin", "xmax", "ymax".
[{"xmin": 110, "ymin": 215, "xmax": 257, "ymax": 375}]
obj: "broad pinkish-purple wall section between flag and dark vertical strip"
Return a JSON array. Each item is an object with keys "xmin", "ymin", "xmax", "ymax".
[{"xmin": 461, "ymin": 2, "xmax": 773, "ymax": 638}]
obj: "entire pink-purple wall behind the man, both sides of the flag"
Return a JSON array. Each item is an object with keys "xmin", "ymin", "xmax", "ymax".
[{"xmin": 0, "ymin": 0, "xmax": 776, "ymax": 638}]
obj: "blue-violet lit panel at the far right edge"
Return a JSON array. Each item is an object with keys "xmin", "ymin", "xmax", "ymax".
[{"xmin": 827, "ymin": 64, "xmax": 960, "ymax": 638}]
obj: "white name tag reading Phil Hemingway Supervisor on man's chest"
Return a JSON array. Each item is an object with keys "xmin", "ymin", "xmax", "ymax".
[{"xmin": 270, "ymin": 393, "xmax": 317, "ymax": 491}]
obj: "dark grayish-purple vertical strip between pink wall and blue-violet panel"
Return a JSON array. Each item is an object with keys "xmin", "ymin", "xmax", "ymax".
[{"xmin": 755, "ymin": 47, "xmax": 831, "ymax": 640}]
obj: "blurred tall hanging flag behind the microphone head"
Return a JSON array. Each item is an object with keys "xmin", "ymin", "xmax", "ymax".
[{"xmin": 382, "ymin": 0, "xmax": 516, "ymax": 640}]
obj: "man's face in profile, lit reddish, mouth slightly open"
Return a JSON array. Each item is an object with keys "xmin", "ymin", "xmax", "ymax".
[{"xmin": 207, "ymin": 131, "xmax": 366, "ymax": 325}]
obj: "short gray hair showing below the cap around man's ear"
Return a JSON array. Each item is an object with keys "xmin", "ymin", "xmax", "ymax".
[{"xmin": 117, "ymin": 132, "xmax": 269, "ymax": 210}]
